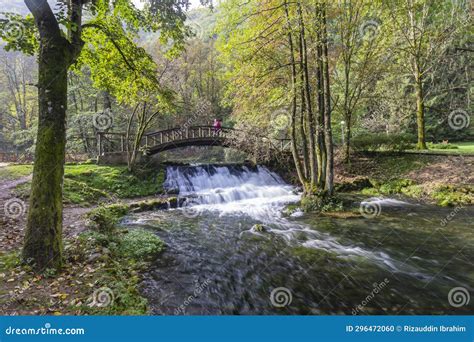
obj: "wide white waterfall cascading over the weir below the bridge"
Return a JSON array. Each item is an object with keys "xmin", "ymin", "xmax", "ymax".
[{"xmin": 164, "ymin": 165, "xmax": 300, "ymax": 219}]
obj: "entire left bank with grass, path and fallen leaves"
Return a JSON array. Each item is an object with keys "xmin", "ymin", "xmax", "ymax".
[{"xmin": 0, "ymin": 164, "xmax": 173, "ymax": 315}]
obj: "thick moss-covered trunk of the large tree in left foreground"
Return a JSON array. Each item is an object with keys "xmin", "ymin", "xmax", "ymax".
[{"xmin": 23, "ymin": 37, "xmax": 69, "ymax": 269}]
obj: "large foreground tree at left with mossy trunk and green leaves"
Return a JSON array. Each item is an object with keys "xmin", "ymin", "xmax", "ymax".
[{"xmin": 0, "ymin": 0, "xmax": 193, "ymax": 269}]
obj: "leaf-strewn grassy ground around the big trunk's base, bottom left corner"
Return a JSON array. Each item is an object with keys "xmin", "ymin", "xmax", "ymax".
[{"xmin": 0, "ymin": 200, "xmax": 164, "ymax": 315}]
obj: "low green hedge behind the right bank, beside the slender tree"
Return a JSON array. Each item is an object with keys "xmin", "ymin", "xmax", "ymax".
[{"xmin": 352, "ymin": 133, "xmax": 415, "ymax": 151}]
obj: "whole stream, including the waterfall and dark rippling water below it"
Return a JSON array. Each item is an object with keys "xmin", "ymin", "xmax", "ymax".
[{"xmin": 122, "ymin": 165, "xmax": 474, "ymax": 315}]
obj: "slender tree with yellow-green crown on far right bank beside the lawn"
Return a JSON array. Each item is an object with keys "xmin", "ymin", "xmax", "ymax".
[{"xmin": 386, "ymin": 0, "xmax": 465, "ymax": 149}]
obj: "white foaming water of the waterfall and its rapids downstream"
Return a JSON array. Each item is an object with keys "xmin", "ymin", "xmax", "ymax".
[{"xmin": 165, "ymin": 165, "xmax": 429, "ymax": 278}]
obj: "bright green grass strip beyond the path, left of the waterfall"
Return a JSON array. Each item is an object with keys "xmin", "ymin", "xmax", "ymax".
[{"xmin": 7, "ymin": 164, "xmax": 165, "ymax": 206}]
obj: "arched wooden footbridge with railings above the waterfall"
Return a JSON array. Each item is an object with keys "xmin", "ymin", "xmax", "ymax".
[{"xmin": 97, "ymin": 126, "xmax": 290, "ymax": 155}]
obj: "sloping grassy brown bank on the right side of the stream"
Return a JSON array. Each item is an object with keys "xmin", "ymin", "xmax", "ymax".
[{"xmin": 336, "ymin": 153, "xmax": 474, "ymax": 206}]
